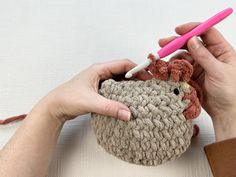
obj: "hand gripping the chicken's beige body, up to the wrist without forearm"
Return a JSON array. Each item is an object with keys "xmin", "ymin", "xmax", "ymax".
[{"xmin": 36, "ymin": 59, "xmax": 151, "ymax": 122}]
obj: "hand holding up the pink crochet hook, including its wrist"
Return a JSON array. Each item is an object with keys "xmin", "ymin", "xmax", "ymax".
[{"xmin": 159, "ymin": 22, "xmax": 236, "ymax": 141}]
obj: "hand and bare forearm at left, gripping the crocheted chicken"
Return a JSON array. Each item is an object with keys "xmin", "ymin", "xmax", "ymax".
[{"xmin": 0, "ymin": 60, "xmax": 151, "ymax": 177}]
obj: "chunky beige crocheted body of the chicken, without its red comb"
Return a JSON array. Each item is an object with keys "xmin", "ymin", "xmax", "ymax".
[{"xmin": 91, "ymin": 79, "xmax": 193, "ymax": 166}]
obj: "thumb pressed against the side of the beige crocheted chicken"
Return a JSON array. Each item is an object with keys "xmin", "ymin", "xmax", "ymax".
[{"xmin": 91, "ymin": 95, "xmax": 131, "ymax": 121}]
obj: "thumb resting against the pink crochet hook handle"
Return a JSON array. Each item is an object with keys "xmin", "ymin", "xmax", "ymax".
[{"xmin": 187, "ymin": 37, "xmax": 219, "ymax": 73}]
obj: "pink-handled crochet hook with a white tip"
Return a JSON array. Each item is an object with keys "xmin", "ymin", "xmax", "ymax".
[{"xmin": 125, "ymin": 8, "xmax": 233, "ymax": 78}]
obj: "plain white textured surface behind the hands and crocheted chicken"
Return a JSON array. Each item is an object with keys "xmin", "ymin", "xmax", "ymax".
[{"xmin": 0, "ymin": 0, "xmax": 236, "ymax": 177}]
